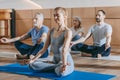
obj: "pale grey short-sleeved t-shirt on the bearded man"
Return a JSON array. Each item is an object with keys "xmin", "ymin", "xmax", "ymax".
[{"xmin": 88, "ymin": 23, "xmax": 112, "ymax": 46}]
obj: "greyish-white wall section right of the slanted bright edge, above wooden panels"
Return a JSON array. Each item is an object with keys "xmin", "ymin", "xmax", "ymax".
[{"xmin": 31, "ymin": 0, "xmax": 120, "ymax": 8}]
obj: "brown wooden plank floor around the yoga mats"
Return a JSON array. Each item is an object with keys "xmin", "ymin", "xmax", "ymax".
[{"xmin": 0, "ymin": 45, "xmax": 120, "ymax": 80}]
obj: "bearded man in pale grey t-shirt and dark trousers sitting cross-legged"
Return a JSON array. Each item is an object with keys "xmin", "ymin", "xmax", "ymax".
[{"xmin": 71, "ymin": 10, "xmax": 112, "ymax": 57}]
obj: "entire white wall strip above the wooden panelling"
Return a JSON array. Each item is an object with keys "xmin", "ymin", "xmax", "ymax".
[{"xmin": 0, "ymin": 0, "xmax": 120, "ymax": 9}]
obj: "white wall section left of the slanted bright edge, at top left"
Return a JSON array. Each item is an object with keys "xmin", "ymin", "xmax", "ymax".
[{"xmin": 0, "ymin": 0, "xmax": 41, "ymax": 10}]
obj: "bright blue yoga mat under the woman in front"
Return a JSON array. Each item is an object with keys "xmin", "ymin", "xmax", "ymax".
[{"xmin": 0, "ymin": 63, "xmax": 115, "ymax": 80}]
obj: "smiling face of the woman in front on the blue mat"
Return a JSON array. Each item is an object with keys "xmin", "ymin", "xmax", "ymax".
[{"xmin": 54, "ymin": 10, "xmax": 64, "ymax": 25}]
